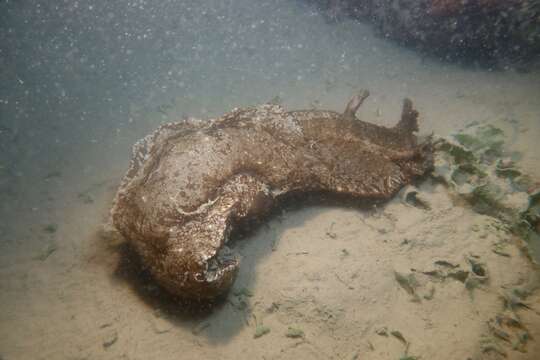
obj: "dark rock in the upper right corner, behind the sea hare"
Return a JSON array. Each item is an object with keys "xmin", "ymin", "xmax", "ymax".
[{"xmin": 311, "ymin": 0, "xmax": 540, "ymax": 65}]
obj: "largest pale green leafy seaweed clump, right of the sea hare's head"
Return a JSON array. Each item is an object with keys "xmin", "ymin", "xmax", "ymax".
[{"xmin": 433, "ymin": 124, "xmax": 540, "ymax": 261}]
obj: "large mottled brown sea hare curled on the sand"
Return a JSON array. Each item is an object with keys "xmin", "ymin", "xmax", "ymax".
[{"xmin": 112, "ymin": 91, "xmax": 432, "ymax": 299}]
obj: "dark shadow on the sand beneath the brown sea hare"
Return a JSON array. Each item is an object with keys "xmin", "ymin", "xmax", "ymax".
[{"xmin": 102, "ymin": 195, "xmax": 384, "ymax": 344}]
